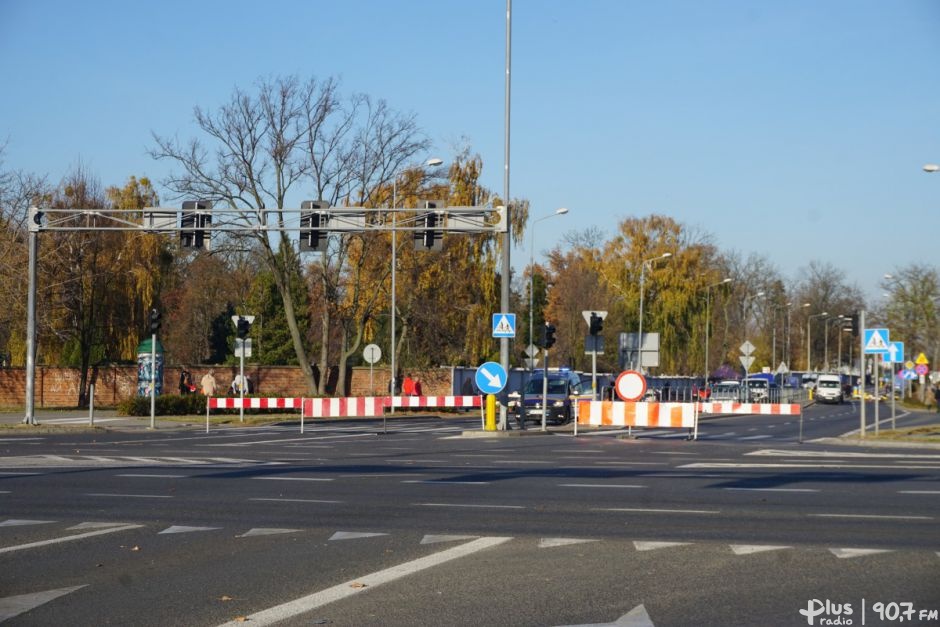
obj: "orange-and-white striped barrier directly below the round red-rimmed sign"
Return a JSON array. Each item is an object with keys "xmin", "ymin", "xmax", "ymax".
[{"xmin": 578, "ymin": 401, "xmax": 697, "ymax": 429}]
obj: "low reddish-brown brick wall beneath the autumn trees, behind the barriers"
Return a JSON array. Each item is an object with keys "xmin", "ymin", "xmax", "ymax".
[{"xmin": 0, "ymin": 365, "xmax": 451, "ymax": 408}]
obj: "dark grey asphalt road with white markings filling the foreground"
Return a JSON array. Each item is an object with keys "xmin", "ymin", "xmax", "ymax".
[{"xmin": 0, "ymin": 404, "xmax": 940, "ymax": 627}]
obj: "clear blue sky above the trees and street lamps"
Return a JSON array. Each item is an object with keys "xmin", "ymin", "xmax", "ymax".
[{"xmin": 0, "ymin": 0, "xmax": 940, "ymax": 297}]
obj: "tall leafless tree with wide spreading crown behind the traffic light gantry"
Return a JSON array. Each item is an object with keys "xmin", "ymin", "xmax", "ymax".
[{"xmin": 151, "ymin": 77, "xmax": 427, "ymax": 394}]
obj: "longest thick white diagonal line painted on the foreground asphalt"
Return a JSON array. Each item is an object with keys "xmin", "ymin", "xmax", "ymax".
[{"xmin": 216, "ymin": 538, "xmax": 512, "ymax": 627}]
